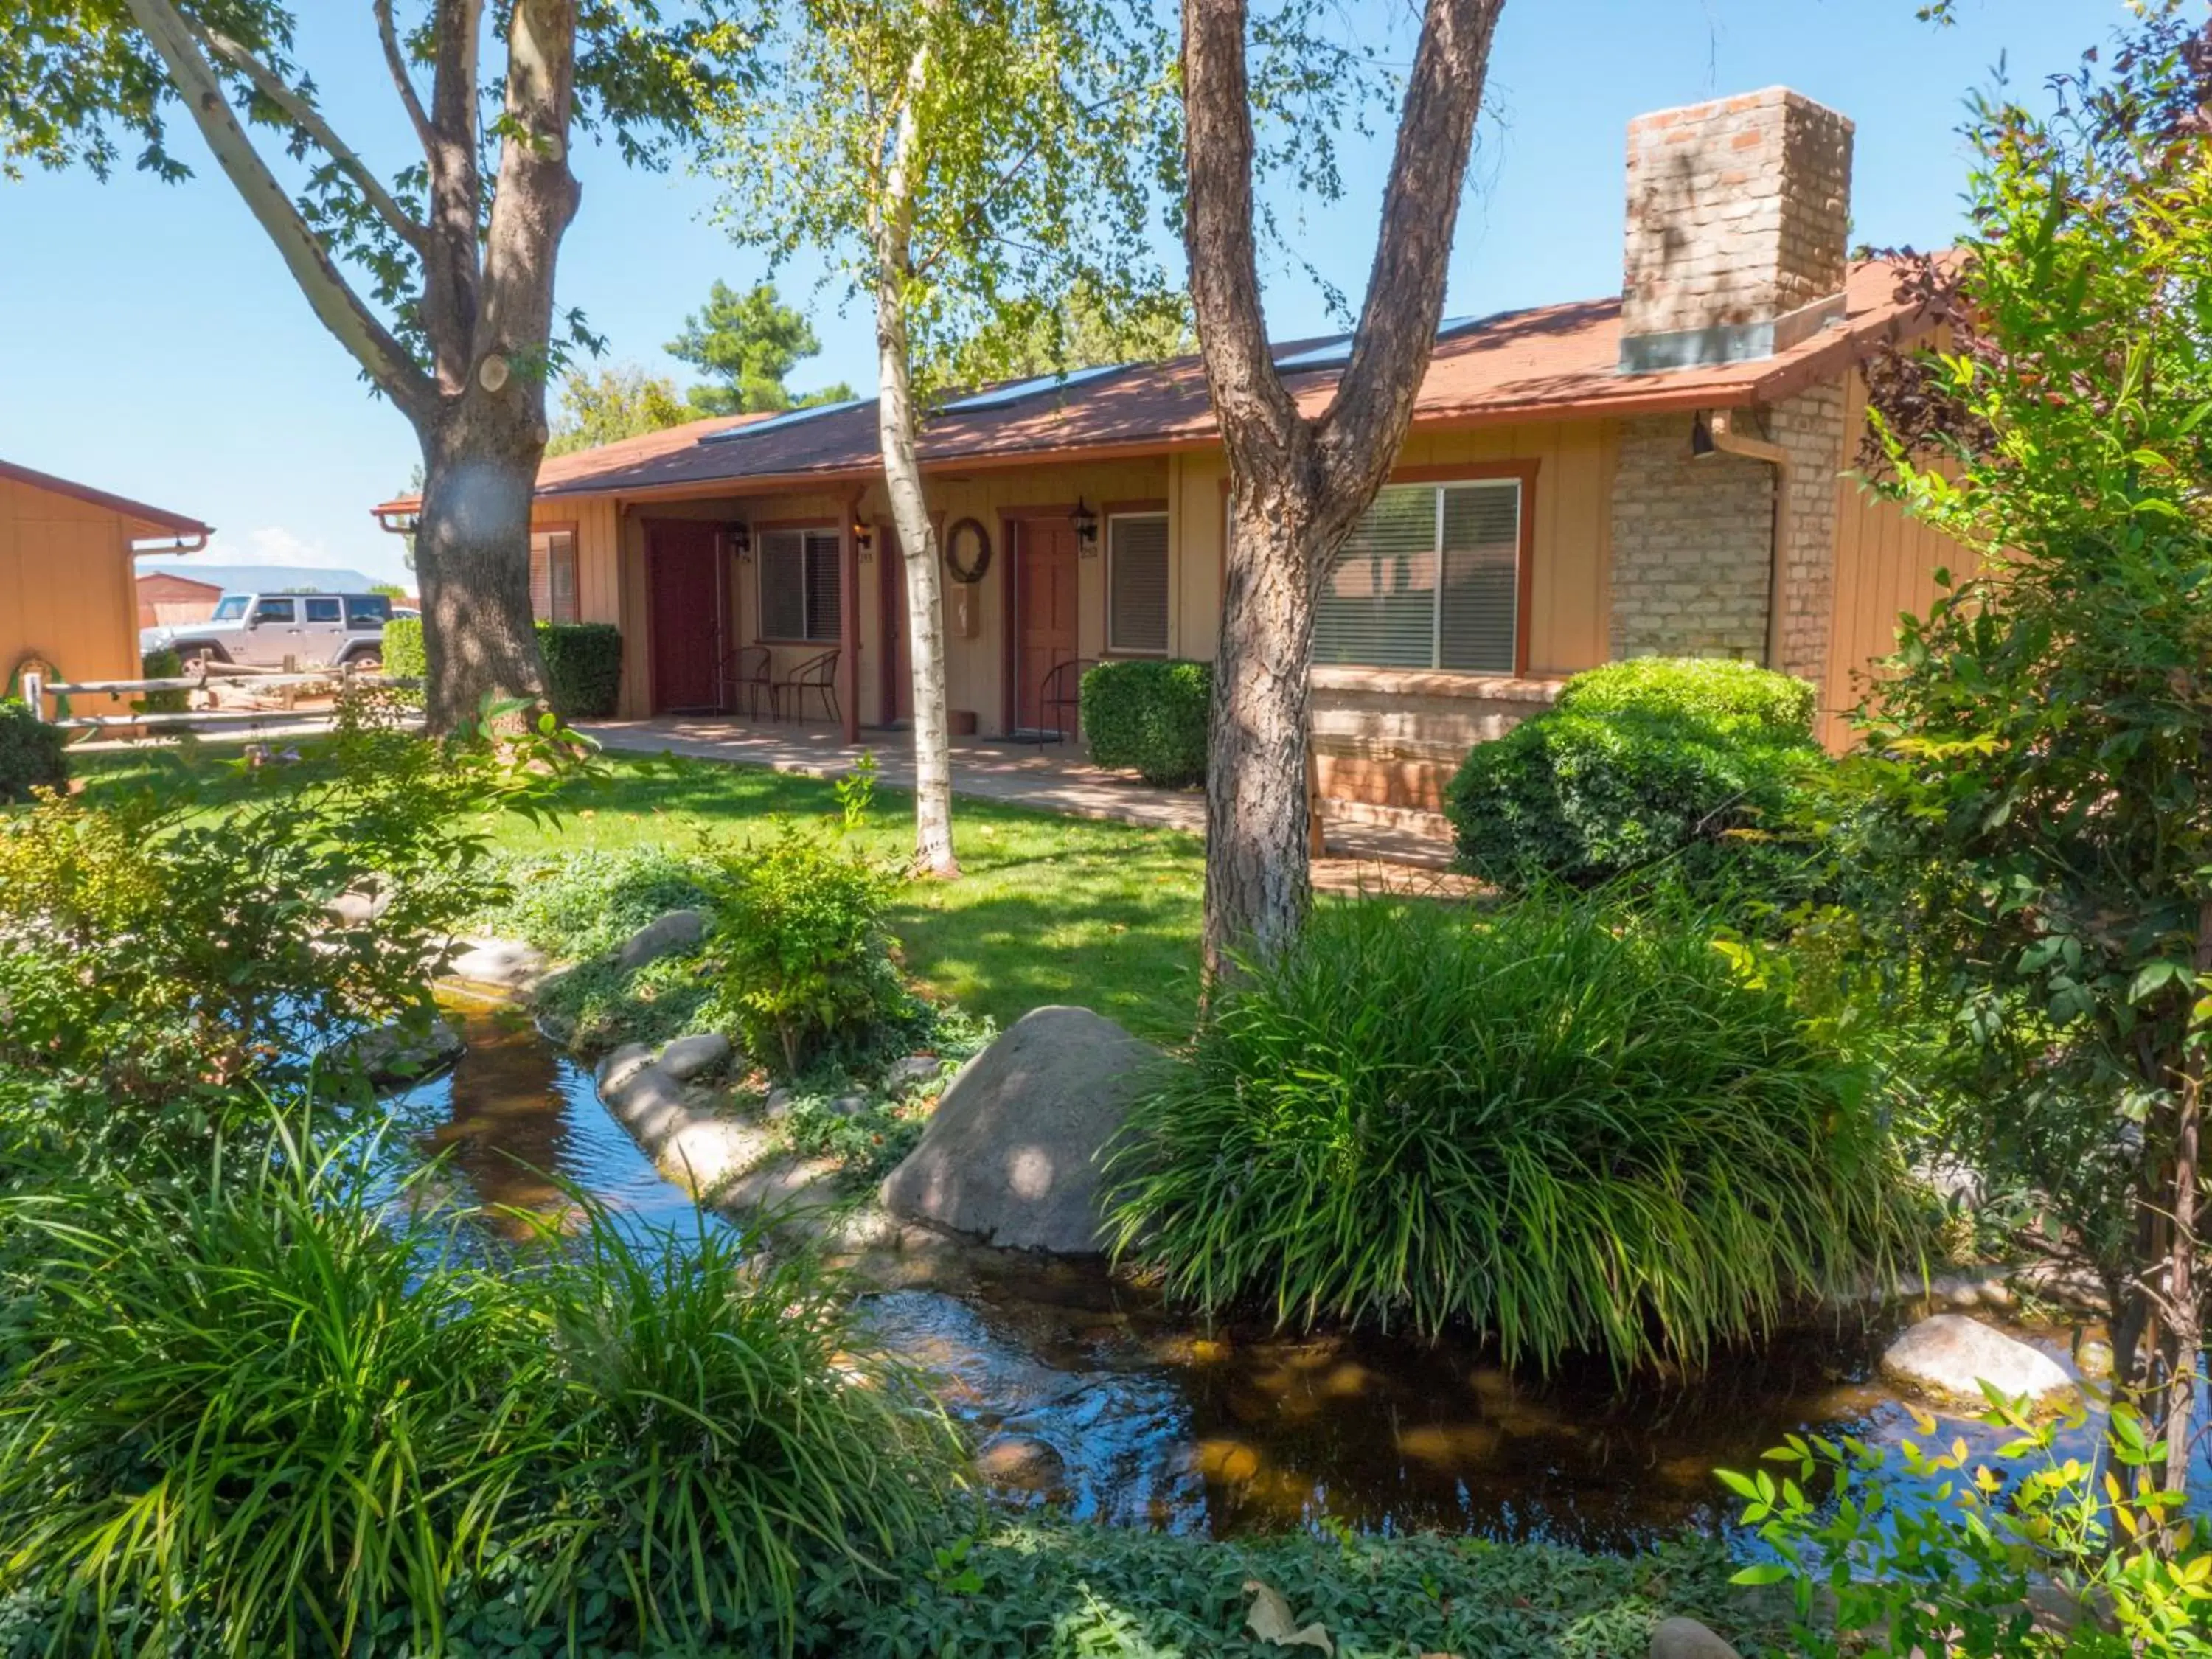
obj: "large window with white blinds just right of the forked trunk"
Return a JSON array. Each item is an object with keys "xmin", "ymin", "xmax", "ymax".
[{"xmin": 1314, "ymin": 478, "xmax": 1522, "ymax": 675}]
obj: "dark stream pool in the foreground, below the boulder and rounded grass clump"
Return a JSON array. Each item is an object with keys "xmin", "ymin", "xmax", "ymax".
[{"xmin": 869, "ymin": 1254, "xmax": 1909, "ymax": 1548}]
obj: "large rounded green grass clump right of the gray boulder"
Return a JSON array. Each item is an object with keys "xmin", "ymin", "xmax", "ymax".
[{"xmin": 1108, "ymin": 896, "xmax": 1911, "ymax": 1374}]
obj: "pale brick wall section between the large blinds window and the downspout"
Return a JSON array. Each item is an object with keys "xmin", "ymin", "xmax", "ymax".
[{"xmin": 1610, "ymin": 414, "xmax": 1774, "ymax": 661}]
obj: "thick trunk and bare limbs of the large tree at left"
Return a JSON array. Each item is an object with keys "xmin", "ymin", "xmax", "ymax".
[{"xmin": 126, "ymin": 0, "xmax": 577, "ymax": 730}]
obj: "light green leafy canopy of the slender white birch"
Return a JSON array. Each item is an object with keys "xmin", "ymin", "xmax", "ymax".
[{"xmin": 712, "ymin": 0, "xmax": 1177, "ymax": 396}]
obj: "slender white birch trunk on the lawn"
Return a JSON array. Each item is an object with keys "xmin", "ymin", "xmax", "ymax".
[{"xmin": 872, "ymin": 13, "xmax": 960, "ymax": 878}]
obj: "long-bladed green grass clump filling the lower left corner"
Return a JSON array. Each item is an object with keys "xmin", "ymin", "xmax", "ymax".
[{"xmin": 0, "ymin": 1130, "xmax": 949, "ymax": 1655}]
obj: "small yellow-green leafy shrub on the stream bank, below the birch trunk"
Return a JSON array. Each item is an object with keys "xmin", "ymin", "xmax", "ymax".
[{"xmin": 712, "ymin": 823, "xmax": 911, "ymax": 1075}]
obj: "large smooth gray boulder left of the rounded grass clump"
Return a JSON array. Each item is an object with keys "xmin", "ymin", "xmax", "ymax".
[{"xmin": 883, "ymin": 1009, "xmax": 1161, "ymax": 1256}]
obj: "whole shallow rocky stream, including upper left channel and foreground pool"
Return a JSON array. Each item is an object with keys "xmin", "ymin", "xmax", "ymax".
[{"xmin": 398, "ymin": 1013, "xmax": 2212, "ymax": 1551}]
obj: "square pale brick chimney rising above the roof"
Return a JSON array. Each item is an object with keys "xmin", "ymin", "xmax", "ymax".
[{"xmin": 1621, "ymin": 86, "xmax": 1851, "ymax": 374}]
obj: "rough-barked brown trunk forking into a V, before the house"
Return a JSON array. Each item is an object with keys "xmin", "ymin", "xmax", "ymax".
[{"xmin": 1183, "ymin": 0, "xmax": 1504, "ymax": 978}]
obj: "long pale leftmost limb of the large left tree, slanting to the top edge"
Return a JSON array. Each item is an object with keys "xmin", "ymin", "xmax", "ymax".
[{"xmin": 126, "ymin": 0, "xmax": 436, "ymax": 420}]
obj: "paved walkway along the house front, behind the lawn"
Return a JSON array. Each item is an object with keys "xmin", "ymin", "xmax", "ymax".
[{"xmin": 577, "ymin": 714, "xmax": 1467, "ymax": 894}]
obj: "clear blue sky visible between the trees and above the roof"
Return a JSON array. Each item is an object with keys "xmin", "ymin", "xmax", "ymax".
[{"xmin": 0, "ymin": 0, "xmax": 2124, "ymax": 575}]
